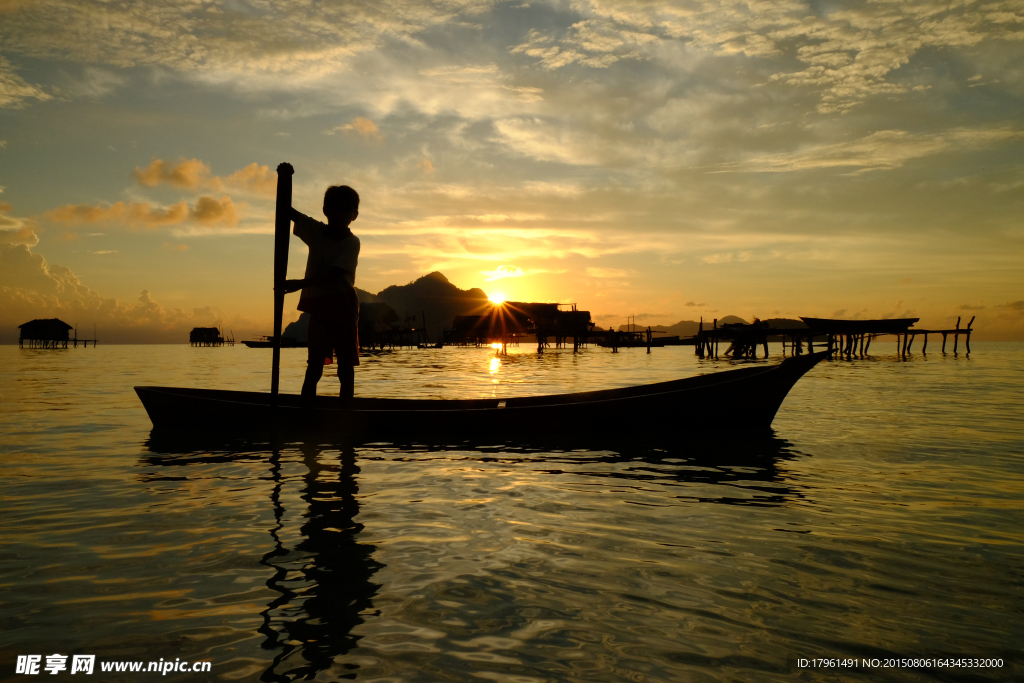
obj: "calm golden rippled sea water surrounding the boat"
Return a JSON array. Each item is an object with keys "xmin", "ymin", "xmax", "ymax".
[{"xmin": 0, "ymin": 342, "xmax": 1024, "ymax": 683}]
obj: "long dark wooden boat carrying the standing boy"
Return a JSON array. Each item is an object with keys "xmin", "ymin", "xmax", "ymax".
[{"xmin": 135, "ymin": 352, "xmax": 827, "ymax": 440}]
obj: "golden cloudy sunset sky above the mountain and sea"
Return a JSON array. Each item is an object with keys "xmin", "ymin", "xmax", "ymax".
[{"xmin": 0, "ymin": 0, "xmax": 1024, "ymax": 343}]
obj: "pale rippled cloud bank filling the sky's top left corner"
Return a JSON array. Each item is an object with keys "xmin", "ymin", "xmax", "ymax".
[{"xmin": 0, "ymin": 0, "xmax": 495, "ymax": 82}]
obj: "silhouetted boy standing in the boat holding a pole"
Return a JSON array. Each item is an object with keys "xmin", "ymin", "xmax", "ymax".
[{"xmin": 285, "ymin": 185, "xmax": 359, "ymax": 402}]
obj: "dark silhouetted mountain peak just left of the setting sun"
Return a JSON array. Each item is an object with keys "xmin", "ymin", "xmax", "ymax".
[{"xmin": 376, "ymin": 271, "xmax": 487, "ymax": 341}]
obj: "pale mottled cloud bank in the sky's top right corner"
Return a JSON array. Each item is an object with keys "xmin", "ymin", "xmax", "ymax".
[{"xmin": 569, "ymin": 0, "xmax": 1024, "ymax": 114}]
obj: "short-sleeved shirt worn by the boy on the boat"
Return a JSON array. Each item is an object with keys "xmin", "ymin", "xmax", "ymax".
[{"xmin": 293, "ymin": 216, "xmax": 359, "ymax": 313}]
